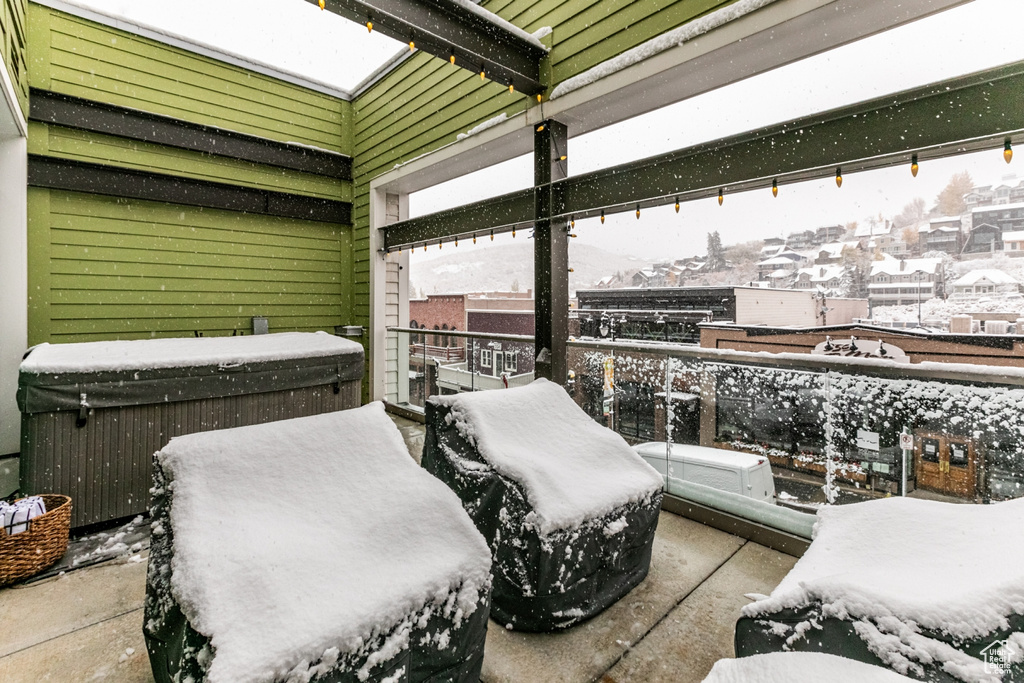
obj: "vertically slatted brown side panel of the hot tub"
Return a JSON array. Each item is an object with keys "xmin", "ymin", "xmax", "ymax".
[{"xmin": 22, "ymin": 380, "xmax": 361, "ymax": 528}]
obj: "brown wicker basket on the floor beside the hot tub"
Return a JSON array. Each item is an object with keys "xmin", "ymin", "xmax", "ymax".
[{"xmin": 0, "ymin": 494, "xmax": 71, "ymax": 586}]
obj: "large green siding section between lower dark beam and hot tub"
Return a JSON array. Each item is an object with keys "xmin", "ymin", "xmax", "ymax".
[{"xmin": 29, "ymin": 187, "xmax": 352, "ymax": 344}]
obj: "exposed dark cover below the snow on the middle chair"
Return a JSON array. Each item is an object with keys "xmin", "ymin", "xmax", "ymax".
[{"xmin": 422, "ymin": 378, "xmax": 663, "ymax": 632}]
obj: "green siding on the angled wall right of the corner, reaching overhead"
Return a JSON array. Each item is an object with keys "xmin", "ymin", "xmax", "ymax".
[{"xmin": 352, "ymin": 0, "xmax": 733, "ymax": 333}]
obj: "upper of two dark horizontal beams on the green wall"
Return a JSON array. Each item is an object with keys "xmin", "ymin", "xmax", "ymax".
[{"xmin": 29, "ymin": 88, "xmax": 352, "ymax": 180}]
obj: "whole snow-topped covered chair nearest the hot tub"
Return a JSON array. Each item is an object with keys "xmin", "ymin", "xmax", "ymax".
[{"xmin": 143, "ymin": 403, "xmax": 490, "ymax": 683}]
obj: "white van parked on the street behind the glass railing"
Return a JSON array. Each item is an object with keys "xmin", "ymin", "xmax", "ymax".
[{"xmin": 633, "ymin": 441, "xmax": 775, "ymax": 504}]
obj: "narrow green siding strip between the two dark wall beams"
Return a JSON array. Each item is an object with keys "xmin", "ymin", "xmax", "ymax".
[{"xmin": 29, "ymin": 121, "xmax": 352, "ymax": 202}]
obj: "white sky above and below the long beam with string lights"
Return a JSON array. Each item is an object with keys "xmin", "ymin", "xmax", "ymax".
[{"xmin": 411, "ymin": 0, "xmax": 1024, "ymax": 261}]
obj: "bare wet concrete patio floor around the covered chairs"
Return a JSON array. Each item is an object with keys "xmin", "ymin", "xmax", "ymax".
[{"xmin": 0, "ymin": 419, "xmax": 797, "ymax": 683}]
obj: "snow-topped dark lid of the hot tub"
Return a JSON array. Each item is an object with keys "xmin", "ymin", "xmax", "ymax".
[{"xmin": 17, "ymin": 332, "xmax": 362, "ymax": 414}]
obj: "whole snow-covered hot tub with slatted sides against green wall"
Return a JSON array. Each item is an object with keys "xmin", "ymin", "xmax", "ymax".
[{"xmin": 17, "ymin": 332, "xmax": 364, "ymax": 527}]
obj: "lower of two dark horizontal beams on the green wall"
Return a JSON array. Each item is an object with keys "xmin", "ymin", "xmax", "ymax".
[{"xmin": 29, "ymin": 155, "xmax": 352, "ymax": 225}]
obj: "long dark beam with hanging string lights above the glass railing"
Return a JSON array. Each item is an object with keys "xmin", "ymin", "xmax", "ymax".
[{"xmin": 385, "ymin": 62, "xmax": 1024, "ymax": 248}]
